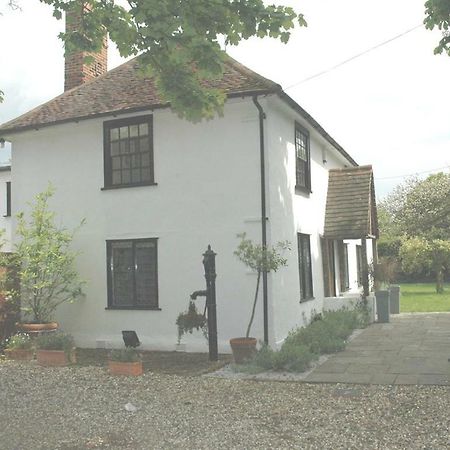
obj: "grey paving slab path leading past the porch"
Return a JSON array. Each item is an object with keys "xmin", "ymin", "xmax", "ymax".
[{"xmin": 304, "ymin": 313, "xmax": 450, "ymax": 386}]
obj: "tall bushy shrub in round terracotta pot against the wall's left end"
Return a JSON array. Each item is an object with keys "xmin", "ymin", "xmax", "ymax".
[{"xmin": 7, "ymin": 186, "xmax": 84, "ymax": 332}]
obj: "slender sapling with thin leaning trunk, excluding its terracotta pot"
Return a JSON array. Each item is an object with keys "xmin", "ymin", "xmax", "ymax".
[{"xmin": 234, "ymin": 233, "xmax": 290, "ymax": 338}]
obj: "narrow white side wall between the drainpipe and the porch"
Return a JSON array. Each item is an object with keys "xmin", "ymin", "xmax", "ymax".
[{"xmin": 265, "ymin": 98, "xmax": 356, "ymax": 345}]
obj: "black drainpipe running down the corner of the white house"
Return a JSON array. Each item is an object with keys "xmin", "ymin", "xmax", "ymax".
[{"xmin": 253, "ymin": 95, "xmax": 269, "ymax": 344}]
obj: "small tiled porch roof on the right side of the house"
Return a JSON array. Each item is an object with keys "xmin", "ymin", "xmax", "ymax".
[{"xmin": 324, "ymin": 166, "xmax": 378, "ymax": 239}]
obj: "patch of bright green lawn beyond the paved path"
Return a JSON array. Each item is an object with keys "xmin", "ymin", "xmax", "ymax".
[{"xmin": 400, "ymin": 283, "xmax": 450, "ymax": 312}]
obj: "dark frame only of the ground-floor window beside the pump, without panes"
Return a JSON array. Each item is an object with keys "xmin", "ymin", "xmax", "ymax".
[{"xmin": 106, "ymin": 238, "xmax": 161, "ymax": 311}]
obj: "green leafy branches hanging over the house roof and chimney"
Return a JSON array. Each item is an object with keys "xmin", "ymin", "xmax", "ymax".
[{"xmin": 39, "ymin": 0, "xmax": 306, "ymax": 121}]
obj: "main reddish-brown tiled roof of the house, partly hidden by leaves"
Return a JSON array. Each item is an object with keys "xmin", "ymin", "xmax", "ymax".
[{"xmin": 0, "ymin": 57, "xmax": 281, "ymax": 134}]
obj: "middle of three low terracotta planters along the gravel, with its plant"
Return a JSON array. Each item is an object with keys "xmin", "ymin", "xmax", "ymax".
[{"xmin": 36, "ymin": 331, "xmax": 76, "ymax": 366}]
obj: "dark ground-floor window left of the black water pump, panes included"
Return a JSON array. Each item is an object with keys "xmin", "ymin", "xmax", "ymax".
[{"xmin": 106, "ymin": 238, "xmax": 159, "ymax": 309}]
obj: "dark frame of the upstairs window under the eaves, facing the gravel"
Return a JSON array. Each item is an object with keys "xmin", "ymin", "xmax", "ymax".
[{"xmin": 102, "ymin": 114, "xmax": 157, "ymax": 190}]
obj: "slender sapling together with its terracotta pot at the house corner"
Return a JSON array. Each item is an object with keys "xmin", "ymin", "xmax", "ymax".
[{"xmin": 230, "ymin": 233, "xmax": 290, "ymax": 364}]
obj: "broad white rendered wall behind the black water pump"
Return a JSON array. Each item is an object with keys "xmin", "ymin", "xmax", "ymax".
[{"xmin": 12, "ymin": 99, "xmax": 272, "ymax": 351}]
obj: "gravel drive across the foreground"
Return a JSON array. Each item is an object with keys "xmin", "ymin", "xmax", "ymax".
[{"xmin": 0, "ymin": 361, "xmax": 450, "ymax": 450}]
